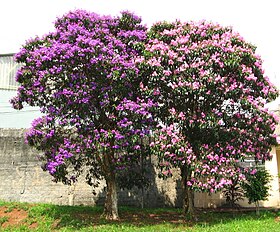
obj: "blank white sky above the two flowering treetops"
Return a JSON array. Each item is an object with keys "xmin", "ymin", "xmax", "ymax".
[{"xmin": 0, "ymin": 0, "xmax": 280, "ymax": 87}]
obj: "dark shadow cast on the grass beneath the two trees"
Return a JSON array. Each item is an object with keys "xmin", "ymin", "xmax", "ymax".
[{"xmin": 25, "ymin": 205, "xmax": 279, "ymax": 230}]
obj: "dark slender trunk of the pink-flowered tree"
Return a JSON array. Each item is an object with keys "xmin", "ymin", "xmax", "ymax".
[{"xmin": 181, "ymin": 166, "xmax": 195, "ymax": 218}]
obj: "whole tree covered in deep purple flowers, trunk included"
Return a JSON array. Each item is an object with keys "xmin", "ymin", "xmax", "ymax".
[{"xmin": 11, "ymin": 10, "xmax": 154, "ymax": 219}]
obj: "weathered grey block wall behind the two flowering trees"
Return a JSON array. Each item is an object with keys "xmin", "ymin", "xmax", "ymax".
[{"xmin": 0, "ymin": 129, "xmax": 184, "ymax": 207}]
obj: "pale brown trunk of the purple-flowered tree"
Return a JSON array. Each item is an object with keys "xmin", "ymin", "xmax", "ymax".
[{"xmin": 103, "ymin": 148, "xmax": 119, "ymax": 220}]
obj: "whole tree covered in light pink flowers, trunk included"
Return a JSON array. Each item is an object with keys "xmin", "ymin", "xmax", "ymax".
[{"xmin": 137, "ymin": 21, "xmax": 278, "ymax": 217}]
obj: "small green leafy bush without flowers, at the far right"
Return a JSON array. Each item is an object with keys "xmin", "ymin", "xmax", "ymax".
[{"xmin": 242, "ymin": 167, "xmax": 271, "ymax": 207}]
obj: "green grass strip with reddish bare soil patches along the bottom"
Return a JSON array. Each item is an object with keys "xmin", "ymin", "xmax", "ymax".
[{"xmin": 0, "ymin": 202, "xmax": 280, "ymax": 232}]
